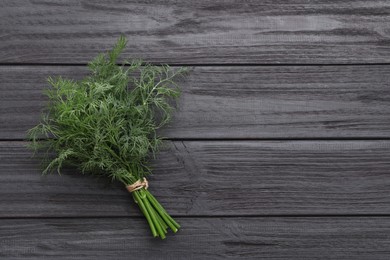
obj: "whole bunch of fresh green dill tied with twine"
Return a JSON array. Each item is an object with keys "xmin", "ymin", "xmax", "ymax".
[{"xmin": 28, "ymin": 36, "xmax": 186, "ymax": 238}]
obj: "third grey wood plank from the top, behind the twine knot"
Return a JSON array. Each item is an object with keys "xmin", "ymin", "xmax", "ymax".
[{"xmin": 0, "ymin": 141, "xmax": 390, "ymax": 218}]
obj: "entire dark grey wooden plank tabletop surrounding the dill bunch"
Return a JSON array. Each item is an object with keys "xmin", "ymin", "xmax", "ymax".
[{"xmin": 0, "ymin": 0, "xmax": 390, "ymax": 260}]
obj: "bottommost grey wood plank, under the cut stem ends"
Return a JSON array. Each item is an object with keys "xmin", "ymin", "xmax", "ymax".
[{"xmin": 0, "ymin": 217, "xmax": 390, "ymax": 260}]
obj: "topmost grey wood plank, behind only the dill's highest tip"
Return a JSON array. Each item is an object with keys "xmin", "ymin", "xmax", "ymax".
[{"xmin": 0, "ymin": 0, "xmax": 390, "ymax": 64}]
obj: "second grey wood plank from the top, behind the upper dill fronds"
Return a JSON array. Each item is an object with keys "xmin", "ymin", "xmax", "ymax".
[{"xmin": 0, "ymin": 66, "xmax": 390, "ymax": 139}]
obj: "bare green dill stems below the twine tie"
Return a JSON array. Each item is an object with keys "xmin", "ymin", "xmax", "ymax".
[{"xmin": 132, "ymin": 188, "xmax": 180, "ymax": 239}]
